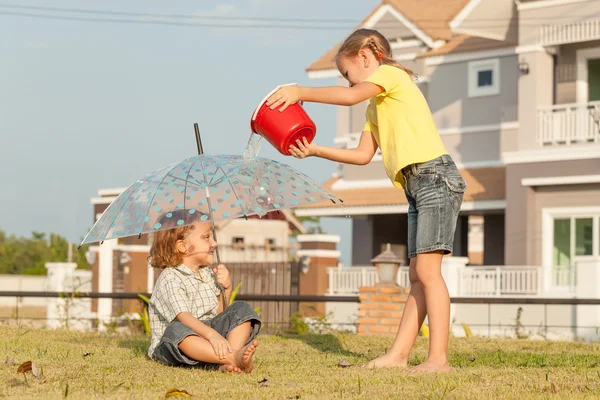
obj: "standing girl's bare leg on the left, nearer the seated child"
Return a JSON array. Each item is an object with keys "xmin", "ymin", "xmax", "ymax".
[{"xmin": 366, "ymin": 257, "xmax": 427, "ymax": 368}]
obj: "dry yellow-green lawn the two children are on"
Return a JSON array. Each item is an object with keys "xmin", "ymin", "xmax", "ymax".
[{"xmin": 0, "ymin": 326, "xmax": 600, "ymax": 400}]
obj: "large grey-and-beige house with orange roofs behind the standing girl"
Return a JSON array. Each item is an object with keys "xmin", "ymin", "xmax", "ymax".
[{"xmin": 296, "ymin": 0, "xmax": 600, "ymax": 278}]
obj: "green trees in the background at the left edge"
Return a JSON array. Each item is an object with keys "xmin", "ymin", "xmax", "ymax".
[{"xmin": 0, "ymin": 230, "xmax": 90, "ymax": 275}]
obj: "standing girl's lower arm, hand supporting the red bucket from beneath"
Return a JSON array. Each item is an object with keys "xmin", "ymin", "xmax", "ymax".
[{"xmin": 290, "ymin": 131, "xmax": 377, "ymax": 165}]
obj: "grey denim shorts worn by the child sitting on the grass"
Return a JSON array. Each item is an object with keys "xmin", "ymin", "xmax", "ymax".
[{"xmin": 152, "ymin": 301, "xmax": 261, "ymax": 366}]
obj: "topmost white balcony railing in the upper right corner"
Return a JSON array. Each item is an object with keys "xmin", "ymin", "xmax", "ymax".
[{"xmin": 540, "ymin": 19, "xmax": 600, "ymax": 46}]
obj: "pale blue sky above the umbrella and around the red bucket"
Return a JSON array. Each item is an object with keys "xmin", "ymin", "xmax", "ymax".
[{"xmin": 0, "ymin": 0, "xmax": 379, "ymax": 262}]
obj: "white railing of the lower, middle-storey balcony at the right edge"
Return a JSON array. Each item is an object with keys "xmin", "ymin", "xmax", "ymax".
[{"xmin": 537, "ymin": 101, "xmax": 600, "ymax": 147}]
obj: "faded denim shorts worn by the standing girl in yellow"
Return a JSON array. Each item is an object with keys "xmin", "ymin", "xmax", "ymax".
[{"xmin": 402, "ymin": 154, "xmax": 467, "ymax": 258}]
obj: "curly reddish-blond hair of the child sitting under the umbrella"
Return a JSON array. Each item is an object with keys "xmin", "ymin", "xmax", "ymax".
[{"xmin": 148, "ymin": 210, "xmax": 203, "ymax": 269}]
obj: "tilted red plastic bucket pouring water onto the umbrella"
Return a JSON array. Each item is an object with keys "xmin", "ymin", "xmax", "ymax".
[{"xmin": 250, "ymin": 85, "xmax": 317, "ymax": 156}]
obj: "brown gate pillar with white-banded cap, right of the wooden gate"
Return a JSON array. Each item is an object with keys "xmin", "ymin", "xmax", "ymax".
[{"xmin": 296, "ymin": 235, "xmax": 340, "ymax": 317}]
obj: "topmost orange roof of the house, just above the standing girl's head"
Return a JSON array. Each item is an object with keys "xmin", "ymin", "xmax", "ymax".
[{"xmin": 306, "ymin": 0, "xmax": 469, "ymax": 71}]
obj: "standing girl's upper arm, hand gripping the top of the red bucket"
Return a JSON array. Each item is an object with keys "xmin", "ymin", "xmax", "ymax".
[{"xmin": 267, "ymin": 82, "xmax": 383, "ymax": 111}]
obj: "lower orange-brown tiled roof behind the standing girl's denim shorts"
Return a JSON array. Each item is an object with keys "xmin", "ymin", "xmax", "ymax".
[{"xmin": 298, "ymin": 167, "xmax": 506, "ymax": 209}]
